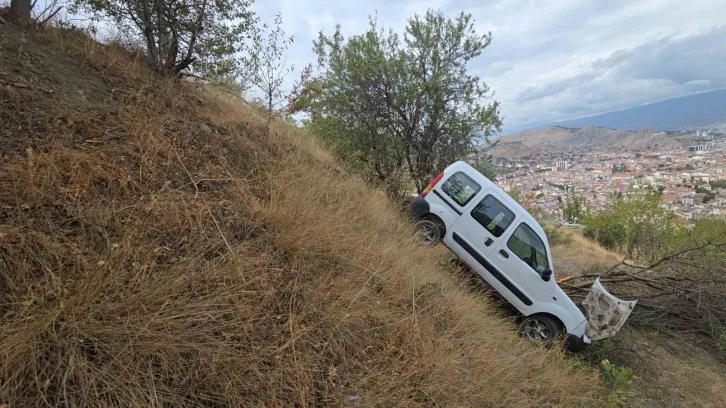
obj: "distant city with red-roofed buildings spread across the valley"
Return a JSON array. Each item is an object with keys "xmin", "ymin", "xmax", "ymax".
[{"xmin": 491, "ymin": 127, "xmax": 726, "ymax": 220}]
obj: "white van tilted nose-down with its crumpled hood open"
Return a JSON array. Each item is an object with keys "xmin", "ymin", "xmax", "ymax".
[{"xmin": 410, "ymin": 161, "xmax": 636, "ymax": 350}]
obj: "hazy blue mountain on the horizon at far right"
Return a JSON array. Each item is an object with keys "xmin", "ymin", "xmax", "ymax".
[{"xmin": 545, "ymin": 89, "xmax": 726, "ymax": 130}]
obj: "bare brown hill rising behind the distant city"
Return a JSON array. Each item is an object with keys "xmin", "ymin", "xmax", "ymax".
[{"xmin": 493, "ymin": 126, "xmax": 681, "ymax": 157}]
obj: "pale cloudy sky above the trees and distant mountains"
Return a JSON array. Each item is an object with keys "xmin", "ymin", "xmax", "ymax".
[{"xmin": 254, "ymin": 0, "xmax": 726, "ymax": 133}]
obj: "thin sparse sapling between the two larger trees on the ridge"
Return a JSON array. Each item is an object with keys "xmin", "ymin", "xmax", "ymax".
[{"xmin": 241, "ymin": 14, "xmax": 294, "ymax": 127}]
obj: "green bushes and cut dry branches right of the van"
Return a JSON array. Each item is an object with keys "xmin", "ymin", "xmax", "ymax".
[{"xmin": 576, "ymin": 191, "xmax": 726, "ymax": 344}]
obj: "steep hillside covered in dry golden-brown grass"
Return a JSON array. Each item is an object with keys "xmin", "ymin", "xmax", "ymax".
[{"xmin": 0, "ymin": 25, "xmax": 599, "ymax": 407}]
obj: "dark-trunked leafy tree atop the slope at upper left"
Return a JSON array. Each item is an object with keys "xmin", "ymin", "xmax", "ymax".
[{"xmin": 73, "ymin": 0, "xmax": 253, "ymax": 76}]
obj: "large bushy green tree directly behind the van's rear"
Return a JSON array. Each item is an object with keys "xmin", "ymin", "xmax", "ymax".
[{"xmin": 297, "ymin": 10, "xmax": 501, "ymax": 195}]
